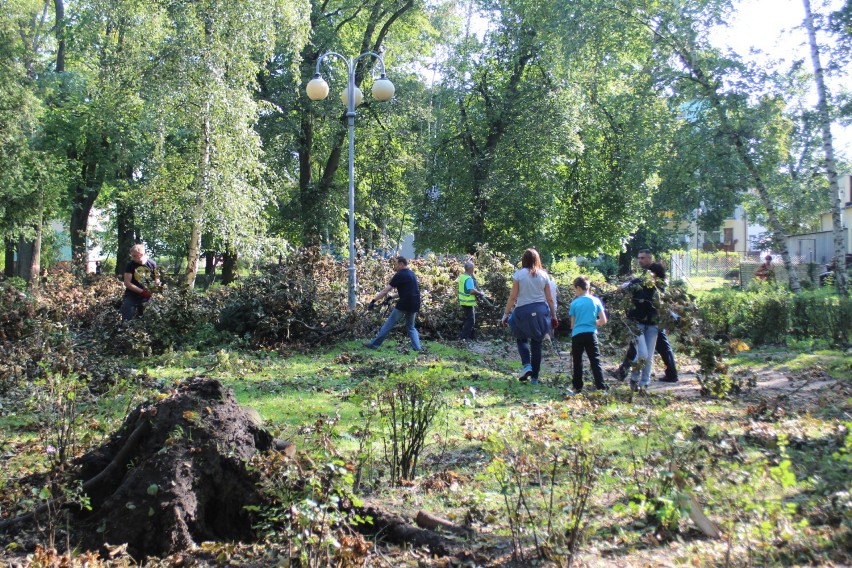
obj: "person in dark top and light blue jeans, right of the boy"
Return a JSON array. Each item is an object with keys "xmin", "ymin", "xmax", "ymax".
[{"xmin": 623, "ymin": 262, "xmax": 666, "ymax": 392}]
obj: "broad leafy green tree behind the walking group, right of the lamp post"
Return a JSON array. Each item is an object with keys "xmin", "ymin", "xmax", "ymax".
[{"xmin": 417, "ymin": 0, "xmax": 673, "ymax": 254}]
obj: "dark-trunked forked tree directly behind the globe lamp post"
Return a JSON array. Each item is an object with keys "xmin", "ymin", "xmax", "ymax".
[{"xmin": 261, "ymin": 0, "xmax": 435, "ymax": 248}]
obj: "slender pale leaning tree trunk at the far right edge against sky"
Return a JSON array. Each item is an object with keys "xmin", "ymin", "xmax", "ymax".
[{"xmin": 802, "ymin": 0, "xmax": 849, "ymax": 296}]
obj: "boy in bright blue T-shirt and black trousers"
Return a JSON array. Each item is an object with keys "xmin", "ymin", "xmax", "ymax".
[{"xmin": 568, "ymin": 276, "xmax": 609, "ymax": 395}]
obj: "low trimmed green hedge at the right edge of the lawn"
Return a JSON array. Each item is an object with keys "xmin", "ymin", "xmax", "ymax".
[{"xmin": 699, "ymin": 285, "xmax": 852, "ymax": 345}]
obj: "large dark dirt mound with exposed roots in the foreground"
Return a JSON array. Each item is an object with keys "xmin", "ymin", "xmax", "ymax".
[{"xmin": 79, "ymin": 378, "xmax": 273, "ymax": 558}]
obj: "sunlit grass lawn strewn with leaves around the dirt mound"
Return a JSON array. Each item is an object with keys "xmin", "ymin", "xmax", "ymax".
[{"xmin": 0, "ymin": 340, "xmax": 852, "ymax": 565}]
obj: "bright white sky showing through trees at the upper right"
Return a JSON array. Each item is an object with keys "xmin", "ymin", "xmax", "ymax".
[{"xmin": 713, "ymin": 0, "xmax": 852, "ymax": 160}]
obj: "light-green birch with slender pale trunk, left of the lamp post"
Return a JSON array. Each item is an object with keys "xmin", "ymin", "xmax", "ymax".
[{"xmin": 140, "ymin": 0, "xmax": 306, "ymax": 286}]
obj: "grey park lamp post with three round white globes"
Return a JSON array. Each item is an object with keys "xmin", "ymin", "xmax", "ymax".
[{"xmin": 305, "ymin": 51, "xmax": 396, "ymax": 310}]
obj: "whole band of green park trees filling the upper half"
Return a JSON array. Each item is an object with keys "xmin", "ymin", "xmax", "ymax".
[{"xmin": 0, "ymin": 0, "xmax": 849, "ymax": 285}]
